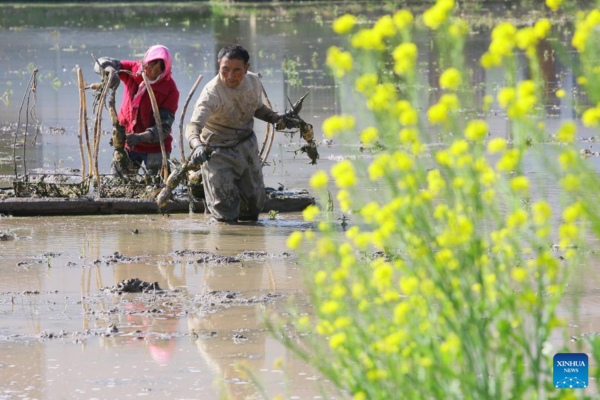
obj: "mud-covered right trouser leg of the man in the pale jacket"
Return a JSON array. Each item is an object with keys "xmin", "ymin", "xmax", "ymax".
[{"xmin": 236, "ymin": 135, "xmax": 266, "ymax": 220}]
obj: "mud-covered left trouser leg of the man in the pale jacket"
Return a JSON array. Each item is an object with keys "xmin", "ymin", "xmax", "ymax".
[{"xmin": 202, "ymin": 146, "xmax": 243, "ymax": 221}]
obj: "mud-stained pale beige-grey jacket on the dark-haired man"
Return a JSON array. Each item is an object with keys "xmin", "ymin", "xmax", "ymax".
[{"xmin": 185, "ymin": 72, "xmax": 280, "ymax": 147}]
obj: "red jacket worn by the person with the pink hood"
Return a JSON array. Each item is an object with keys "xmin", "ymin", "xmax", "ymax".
[{"xmin": 119, "ymin": 54, "xmax": 179, "ymax": 153}]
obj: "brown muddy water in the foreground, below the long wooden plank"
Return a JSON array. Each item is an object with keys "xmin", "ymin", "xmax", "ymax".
[{"xmin": 0, "ymin": 215, "xmax": 330, "ymax": 399}]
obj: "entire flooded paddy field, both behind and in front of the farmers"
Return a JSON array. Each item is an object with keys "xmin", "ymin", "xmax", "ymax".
[{"xmin": 0, "ymin": 2, "xmax": 600, "ymax": 399}]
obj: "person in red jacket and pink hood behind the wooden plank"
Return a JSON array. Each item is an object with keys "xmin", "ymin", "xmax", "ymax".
[{"xmin": 94, "ymin": 45, "xmax": 179, "ymax": 175}]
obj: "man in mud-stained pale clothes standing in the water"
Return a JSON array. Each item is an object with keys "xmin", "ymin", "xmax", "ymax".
[{"xmin": 186, "ymin": 45, "xmax": 282, "ymax": 222}]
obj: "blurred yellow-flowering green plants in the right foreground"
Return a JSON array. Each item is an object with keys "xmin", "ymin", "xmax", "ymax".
[{"xmin": 271, "ymin": 0, "xmax": 600, "ymax": 399}]
